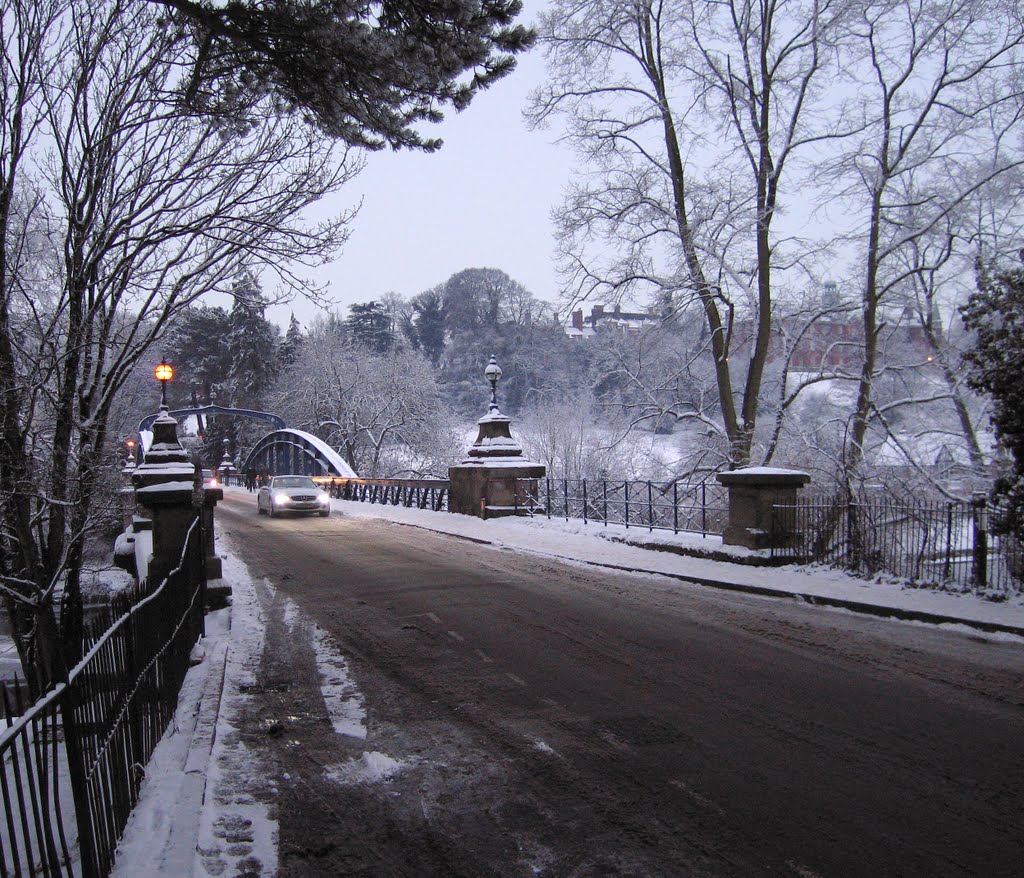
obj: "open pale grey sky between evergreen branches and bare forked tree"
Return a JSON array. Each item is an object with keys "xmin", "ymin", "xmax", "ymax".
[{"xmin": 268, "ymin": 0, "xmax": 571, "ymax": 328}]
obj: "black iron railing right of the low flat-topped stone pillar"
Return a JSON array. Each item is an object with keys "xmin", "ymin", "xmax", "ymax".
[{"xmin": 772, "ymin": 497, "xmax": 1024, "ymax": 592}]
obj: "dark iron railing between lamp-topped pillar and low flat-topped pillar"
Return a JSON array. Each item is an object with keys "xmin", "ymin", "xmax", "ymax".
[{"xmin": 516, "ymin": 478, "xmax": 728, "ymax": 536}]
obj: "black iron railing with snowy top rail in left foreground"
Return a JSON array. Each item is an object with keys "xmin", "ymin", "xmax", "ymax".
[{"xmin": 0, "ymin": 519, "xmax": 205, "ymax": 878}]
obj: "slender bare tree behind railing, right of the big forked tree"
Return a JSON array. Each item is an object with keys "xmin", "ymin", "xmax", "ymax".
[{"xmin": 821, "ymin": 0, "xmax": 1024, "ymax": 471}]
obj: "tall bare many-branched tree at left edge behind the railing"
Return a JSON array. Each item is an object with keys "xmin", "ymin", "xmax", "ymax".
[{"xmin": 0, "ymin": 0, "xmax": 357, "ymax": 688}]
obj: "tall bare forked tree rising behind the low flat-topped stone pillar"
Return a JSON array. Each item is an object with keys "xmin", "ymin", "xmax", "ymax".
[{"xmin": 530, "ymin": 0, "xmax": 845, "ymax": 464}]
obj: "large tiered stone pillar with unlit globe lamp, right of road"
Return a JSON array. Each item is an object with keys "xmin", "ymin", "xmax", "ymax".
[{"xmin": 449, "ymin": 357, "xmax": 547, "ymax": 518}]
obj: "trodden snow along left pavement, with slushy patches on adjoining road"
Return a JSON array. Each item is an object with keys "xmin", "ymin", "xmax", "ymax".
[{"xmin": 113, "ymin": 520, "xmax": 376, "ymax": 878}]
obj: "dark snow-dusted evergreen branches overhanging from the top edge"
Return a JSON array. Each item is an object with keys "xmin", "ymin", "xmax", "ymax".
[{"xmin": 159, "ymin": 0, "xmax": 534, "ymax": 151}]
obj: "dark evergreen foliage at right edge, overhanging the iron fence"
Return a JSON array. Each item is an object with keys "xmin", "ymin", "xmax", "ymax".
[{"xmin": 961, "ymin": 252, "xmax": 1024, "ymax": 539}]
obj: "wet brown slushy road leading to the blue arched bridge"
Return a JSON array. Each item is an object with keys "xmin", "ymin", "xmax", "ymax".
[{"xmin": 112, "ymin": 492, "xmax": 1024, "ymax": 875}]
